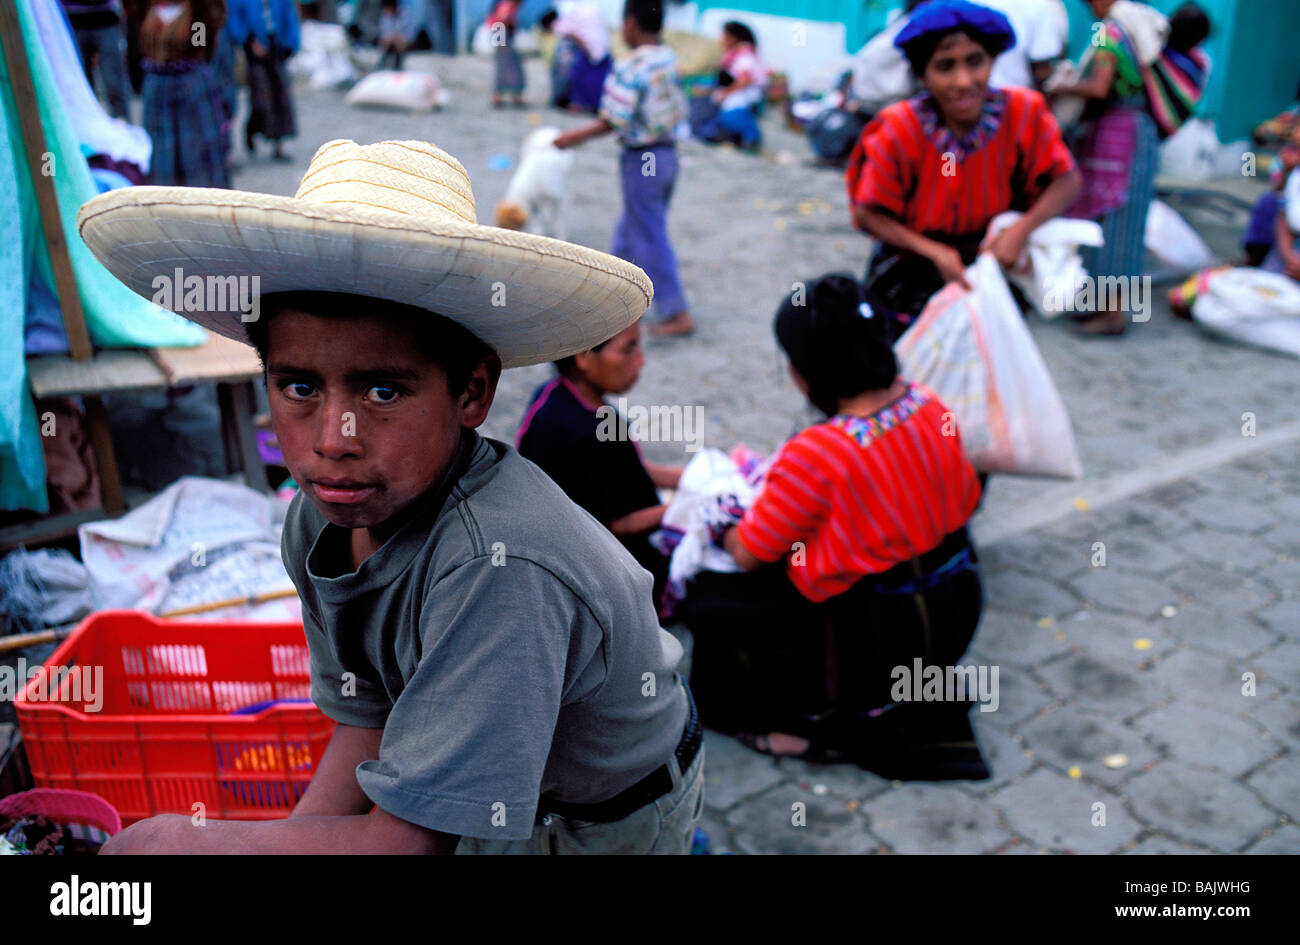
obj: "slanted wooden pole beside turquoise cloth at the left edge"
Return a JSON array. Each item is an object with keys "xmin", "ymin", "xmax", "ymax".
[{"xmin": 0, "ymin": 0, "xmax": 126, "ymax": 517}]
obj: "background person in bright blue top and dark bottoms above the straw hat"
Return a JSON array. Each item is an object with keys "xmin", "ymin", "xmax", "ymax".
[{"xmin": 230, "ymin": 0, "xmax": 299, "ymax": 161}]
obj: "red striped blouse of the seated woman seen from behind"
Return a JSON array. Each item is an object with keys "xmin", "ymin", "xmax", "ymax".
[{"xmin": 738, "ymin": 383, "xmax": 980, "ymax": 603}]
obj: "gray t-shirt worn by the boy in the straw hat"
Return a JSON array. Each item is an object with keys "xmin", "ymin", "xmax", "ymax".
[{"xmin": 281, "ymin": 432, "xmax": 688, "ymax": 840}]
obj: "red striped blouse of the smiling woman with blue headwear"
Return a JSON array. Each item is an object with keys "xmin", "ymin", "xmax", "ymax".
[{"xmin": 845, "ymin": 87, "xmax": 1075, "ymax": 235}]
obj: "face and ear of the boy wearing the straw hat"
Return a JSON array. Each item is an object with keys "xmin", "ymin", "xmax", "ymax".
[{"xmin": 267, "ymin": 309, "xmax": 501, "ymax": 542}]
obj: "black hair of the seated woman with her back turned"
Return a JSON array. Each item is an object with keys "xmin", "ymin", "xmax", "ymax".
[{"xmin": 774, "ymin": 273, "xmax": 898, "ymax": 417}]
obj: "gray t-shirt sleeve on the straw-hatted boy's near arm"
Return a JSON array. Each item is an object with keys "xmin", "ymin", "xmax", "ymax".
[{"xmin": 358, "ymin": 556, "xmax": 585, "ymax": 840}]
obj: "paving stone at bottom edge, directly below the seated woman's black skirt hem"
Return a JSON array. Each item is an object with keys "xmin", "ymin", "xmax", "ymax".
[{"xmin": 867, "ymin": 784, "xmax": 1011, "ymax": 854}]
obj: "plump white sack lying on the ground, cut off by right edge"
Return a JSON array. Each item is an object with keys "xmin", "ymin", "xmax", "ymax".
[{"xmin": 1192, "ymin": 269, "xmax": 1300, "ymax": 357}]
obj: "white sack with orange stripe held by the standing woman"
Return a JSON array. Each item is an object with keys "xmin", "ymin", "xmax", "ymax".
[{"xmin": 894, "ymin": 252, "xmax": 1083, "ymax": 478}]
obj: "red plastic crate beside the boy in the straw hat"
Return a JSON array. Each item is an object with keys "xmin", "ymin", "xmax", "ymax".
[{"xmin": 14, "ymin": 610, "xmax": 334, "ymax": 824}]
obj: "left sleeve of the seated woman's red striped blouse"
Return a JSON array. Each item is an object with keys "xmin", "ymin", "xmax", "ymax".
[{"xmin": 737, "ymin": 438, "xmax": 829, "ymax": 563}]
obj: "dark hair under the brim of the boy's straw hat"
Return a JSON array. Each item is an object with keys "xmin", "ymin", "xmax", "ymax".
[{"xmin": 244, "ymin": 291, "xmax": 495, "ymax": 396}]
